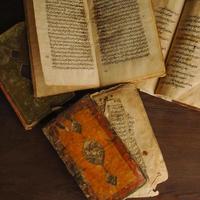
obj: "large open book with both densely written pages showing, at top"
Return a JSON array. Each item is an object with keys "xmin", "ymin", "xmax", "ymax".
[{"xmin": 24, "ymin": 0, "xmax": 165, "ymax": 96}]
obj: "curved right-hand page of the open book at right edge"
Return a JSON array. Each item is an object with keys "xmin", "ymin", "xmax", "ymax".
[{"xmin": 157, "ymin": 0, "xmax": 200, "ymax": 109}]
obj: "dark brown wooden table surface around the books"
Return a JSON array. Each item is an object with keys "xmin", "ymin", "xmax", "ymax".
[{"xmin": 0, "ymin": 0, "xmax": 200, "ymax": 200}]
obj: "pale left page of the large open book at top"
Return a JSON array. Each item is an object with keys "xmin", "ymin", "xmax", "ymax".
[{"xmin": 33, "ymin": 0, "xmax": 99, "ymax": 87}]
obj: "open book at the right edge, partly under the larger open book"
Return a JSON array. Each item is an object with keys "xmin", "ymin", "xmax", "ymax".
[{"xmin": 138, "ymin": 0, "xmax": 200, "ymax": 109}]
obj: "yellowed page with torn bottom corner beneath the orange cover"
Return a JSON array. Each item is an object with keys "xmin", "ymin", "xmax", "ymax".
[{"xmin": 91, "ymin": 84, "xmax": 168, "ymax": 197}]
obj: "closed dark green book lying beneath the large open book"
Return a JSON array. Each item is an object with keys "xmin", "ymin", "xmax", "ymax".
[{"xmin": 0, "ymin": 22, "xmax": 73, "ymax": 129}]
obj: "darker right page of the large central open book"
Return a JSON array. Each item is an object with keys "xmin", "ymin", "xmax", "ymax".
[{"xmin": 88, "ymin": 0, "xmax": 165, "ymax": 86}]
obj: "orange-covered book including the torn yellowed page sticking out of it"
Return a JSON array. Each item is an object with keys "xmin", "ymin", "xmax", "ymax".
[{"xmin": 43, "ymin": 84, "xmax": 168, "ymax": 200}]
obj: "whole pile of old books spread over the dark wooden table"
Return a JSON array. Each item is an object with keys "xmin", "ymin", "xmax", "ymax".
[{"xmin": 0, "ymin": 0, "xmax": 200, "ymax": 200}]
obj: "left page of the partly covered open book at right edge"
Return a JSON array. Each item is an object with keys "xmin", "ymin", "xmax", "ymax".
[{"xmin": 138, "ymin": 0, "xmax": 185, "ymax": 94}]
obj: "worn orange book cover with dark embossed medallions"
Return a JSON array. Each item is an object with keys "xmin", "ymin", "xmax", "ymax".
[{"xmin": 43, "ymin": 97, "xmax": 146, "ymax": 200}]
